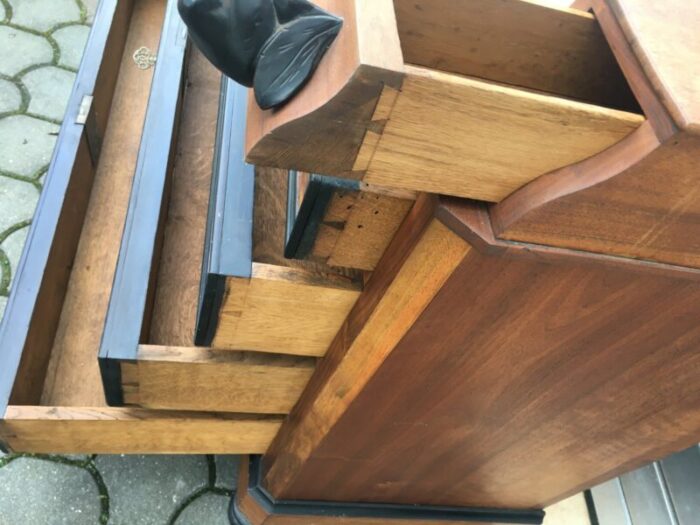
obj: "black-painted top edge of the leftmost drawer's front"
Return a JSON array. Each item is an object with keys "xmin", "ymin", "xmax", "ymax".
[{"xmin": 0, "ymin": 0, "xmax": 130, "ymax": 415}]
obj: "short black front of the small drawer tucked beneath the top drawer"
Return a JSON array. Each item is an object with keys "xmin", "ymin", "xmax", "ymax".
[{"xmin": 284, "ymin": 175, "xmax": 360, "ymax": 259}]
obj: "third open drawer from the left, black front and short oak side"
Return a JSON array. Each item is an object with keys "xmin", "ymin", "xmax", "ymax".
[{"xmin": 196, "ymin": 81, "xmax": 363, "ymax": 356}]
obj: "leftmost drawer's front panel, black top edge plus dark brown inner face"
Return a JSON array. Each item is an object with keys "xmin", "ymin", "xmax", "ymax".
[{"xmin": 0, "ymin": 1, "xmax": 131, "ymax": 413}]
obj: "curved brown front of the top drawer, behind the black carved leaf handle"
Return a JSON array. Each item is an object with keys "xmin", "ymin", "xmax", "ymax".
[{"xmin": 246, "ymin": 0, "xmax": 403, "ymax": 175}]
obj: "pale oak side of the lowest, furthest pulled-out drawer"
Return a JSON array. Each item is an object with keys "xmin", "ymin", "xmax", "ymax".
[{"xmin": 0, "ymin": 406, "xmax": 282, "ymax": 454}]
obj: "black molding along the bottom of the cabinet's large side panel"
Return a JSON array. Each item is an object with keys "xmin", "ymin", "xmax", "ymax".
[{"xmin": 229, "ymin": 456, "xmax": 544, "ymax": 525}]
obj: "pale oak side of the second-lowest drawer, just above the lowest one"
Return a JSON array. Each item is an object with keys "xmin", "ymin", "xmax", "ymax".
[{"xmin": 122, "ymin": 345, "xmax": 315, "ymax": 414}]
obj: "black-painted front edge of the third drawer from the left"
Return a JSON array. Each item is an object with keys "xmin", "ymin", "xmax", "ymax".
[{"xmin": 195, "ymin": 77, "xmax": 255, "ymax": 346}]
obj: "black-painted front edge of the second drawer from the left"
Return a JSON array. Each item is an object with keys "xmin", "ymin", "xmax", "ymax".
[{"xmin": 99, "ymin": 0, "xmax": 187, "ymax": 405}]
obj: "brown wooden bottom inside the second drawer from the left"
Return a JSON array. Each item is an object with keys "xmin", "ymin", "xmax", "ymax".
[{"xmin": 149, "ymin": 49, "xmax": 221, "ymax": 346}]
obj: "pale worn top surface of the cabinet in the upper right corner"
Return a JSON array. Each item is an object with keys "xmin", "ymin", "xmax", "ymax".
[{"xmin": 609, "ymin": 0, "xmax": 700, "ymax": 133}]
